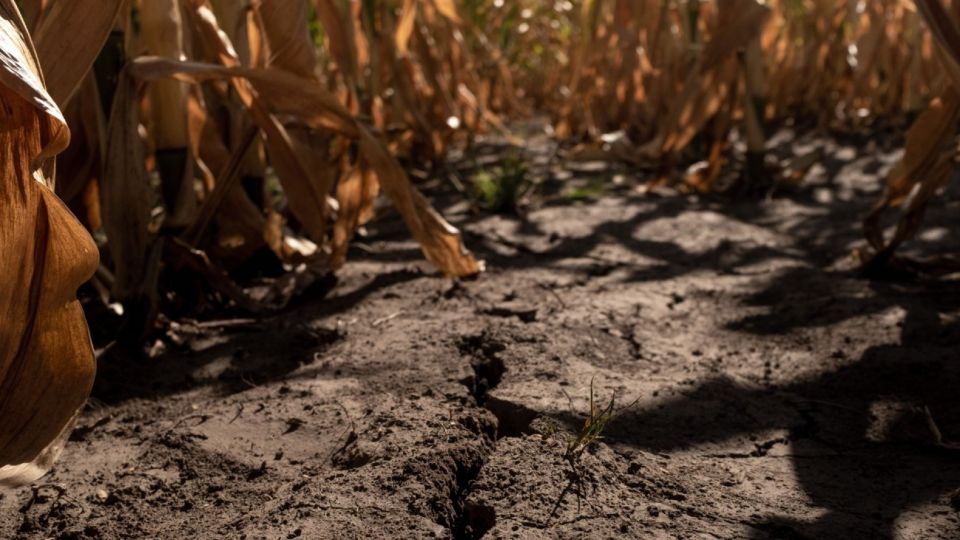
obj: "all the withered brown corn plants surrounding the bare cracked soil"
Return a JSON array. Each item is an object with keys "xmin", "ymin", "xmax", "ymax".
[{"xmin": 0, "ymin": 0, "xmax": 960, "ymax": 502}]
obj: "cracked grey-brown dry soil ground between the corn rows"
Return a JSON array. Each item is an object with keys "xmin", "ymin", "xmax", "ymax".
[{"xmin": 0, "ymin": 132, "xmax": 960, "ymax": 539}]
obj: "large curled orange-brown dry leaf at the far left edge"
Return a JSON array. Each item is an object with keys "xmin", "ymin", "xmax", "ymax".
[{"xmin": 0, "ymin": 0, "xmax": 97, "ymax": 482}]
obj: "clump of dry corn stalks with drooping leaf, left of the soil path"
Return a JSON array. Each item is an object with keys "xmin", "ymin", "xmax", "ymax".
[{"xmin": 69, "ymin": 0, "xmax": 482, "ymax": 332}]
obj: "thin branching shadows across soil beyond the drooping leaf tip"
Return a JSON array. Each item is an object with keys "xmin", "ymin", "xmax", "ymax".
[{"xmin": 442, "ymin": 139, "xmax": 889, "ymax": 282}]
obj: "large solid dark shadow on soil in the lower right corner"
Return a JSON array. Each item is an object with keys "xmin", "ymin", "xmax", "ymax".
[{"xmin": 588, "ymin": 282, "xmax": 960, "ymax": 538}]
